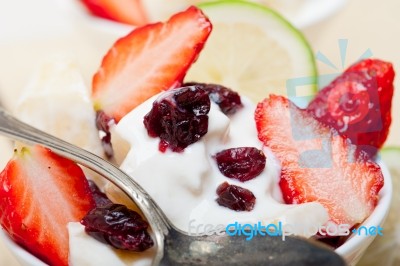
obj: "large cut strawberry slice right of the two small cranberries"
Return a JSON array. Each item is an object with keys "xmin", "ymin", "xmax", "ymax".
[{"xmin": 255, "ymin": 95, "xmax": 383, "ymax": 226}]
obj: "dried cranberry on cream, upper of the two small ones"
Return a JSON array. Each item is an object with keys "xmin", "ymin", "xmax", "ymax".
[{"xmin": 214, "ymin": 147, "xmax": 266, "ymax": 182}]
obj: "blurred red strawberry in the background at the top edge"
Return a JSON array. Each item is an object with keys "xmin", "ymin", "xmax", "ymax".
[{"xmin": 82, "ymin": 0, "xmax": 147, "ymax": 25}]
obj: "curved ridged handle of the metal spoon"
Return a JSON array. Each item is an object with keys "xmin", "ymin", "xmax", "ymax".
[{"xmin": 0, "ymin": 108, "xmax": 170, "ymax": 256}]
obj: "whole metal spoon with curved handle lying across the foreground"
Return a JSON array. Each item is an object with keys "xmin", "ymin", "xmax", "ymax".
[{"xmin": 0, "ymin": 108, "xmax": 345, "ymax": 266}]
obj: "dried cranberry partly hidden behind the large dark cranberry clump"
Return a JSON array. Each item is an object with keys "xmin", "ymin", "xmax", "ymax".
[{"xmin": 184, "ymin": 82, "xmax": 243, "ymax": 115}]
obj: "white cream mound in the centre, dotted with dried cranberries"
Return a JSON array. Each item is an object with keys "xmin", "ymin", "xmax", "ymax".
[{"xmin": 108, "ymin": 91, "xmax": 328, "ymax": 232}]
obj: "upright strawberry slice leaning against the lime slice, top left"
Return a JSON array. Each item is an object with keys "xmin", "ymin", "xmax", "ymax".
[{"xmin": 92, "ymin": 7, "xmax": 212, "ymax": 122}]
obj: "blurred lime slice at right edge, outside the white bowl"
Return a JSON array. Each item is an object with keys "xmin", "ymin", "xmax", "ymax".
[{"xmin": 357, "ymin": 147, "xmax": 400, "ymax": 266}]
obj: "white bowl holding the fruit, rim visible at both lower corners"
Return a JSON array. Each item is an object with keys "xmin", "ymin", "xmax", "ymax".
[{"xmin": 0, "ymin": 159, "xmax": 392, "ymax": 266}]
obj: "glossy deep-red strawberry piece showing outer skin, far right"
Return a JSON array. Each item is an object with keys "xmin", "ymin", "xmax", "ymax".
[{"xmin": 307, "ymin": 59, "xmax": 394, "ymax": 156}]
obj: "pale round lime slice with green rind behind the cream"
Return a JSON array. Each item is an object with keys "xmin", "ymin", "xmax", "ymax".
[{"xmin": 186, "ymin": 0, "xmax": 317, "ymax": 105}]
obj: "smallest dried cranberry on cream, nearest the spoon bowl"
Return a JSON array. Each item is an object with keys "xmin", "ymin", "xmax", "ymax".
[{"xmin": 217, "ymin": 182, "xmax": 256, "ymax": 211}]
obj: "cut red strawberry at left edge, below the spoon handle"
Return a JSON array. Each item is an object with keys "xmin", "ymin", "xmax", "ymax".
[{"xmin": 0, "ymin": 146, "xmax": 95, "ymax": 265}]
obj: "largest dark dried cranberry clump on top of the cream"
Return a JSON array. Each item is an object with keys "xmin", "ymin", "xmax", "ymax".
[{"xmin": 143, "ymin": 86, "xmax": 211, "ymax": 152}]
